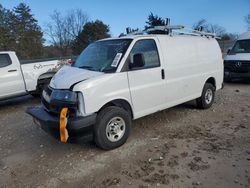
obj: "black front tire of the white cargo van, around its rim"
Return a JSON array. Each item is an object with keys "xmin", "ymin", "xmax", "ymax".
[{"xmin": 94, "ymin": 106, "xmax": 131, "ymax": 150}]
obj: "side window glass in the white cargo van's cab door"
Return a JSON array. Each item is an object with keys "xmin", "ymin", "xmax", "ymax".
[{"xmin": 129, "ymin": 39, "xmax": 160, "ymax": 69}]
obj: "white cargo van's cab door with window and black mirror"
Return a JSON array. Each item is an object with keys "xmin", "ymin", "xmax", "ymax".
[{"xmin": 126, "ymin": 39, "xmax": 166, "ymax": 118}]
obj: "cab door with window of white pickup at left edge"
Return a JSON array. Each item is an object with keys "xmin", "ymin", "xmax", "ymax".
[{"xmin": 0, "ymin": 53, "xmax": 25, "ymax": 99}]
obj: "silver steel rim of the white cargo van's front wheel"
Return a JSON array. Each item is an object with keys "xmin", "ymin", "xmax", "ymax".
[{"xmin": 106, "ymin": 117, "xmax": 126, "ymax": 142}]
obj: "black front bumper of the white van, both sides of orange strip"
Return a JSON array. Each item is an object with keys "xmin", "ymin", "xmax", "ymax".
[{"xmin": 26, "ymin": 107, "xmax": 96, "ymax": 143}]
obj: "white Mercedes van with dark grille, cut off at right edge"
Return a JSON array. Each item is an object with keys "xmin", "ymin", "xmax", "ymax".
[{"xmin": 224, "ymin": 31, "xmax": 250, "ymax": 81}]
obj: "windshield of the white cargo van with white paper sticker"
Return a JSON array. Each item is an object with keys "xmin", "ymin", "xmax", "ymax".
[{"xmin": 73, "ymin": 39, "xmax": 132, "ymax": 72}]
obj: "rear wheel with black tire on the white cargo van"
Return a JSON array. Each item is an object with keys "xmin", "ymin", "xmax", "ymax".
[{"xmin": 196, "ymin": 83, "xmax": 215, "ymax": 109}]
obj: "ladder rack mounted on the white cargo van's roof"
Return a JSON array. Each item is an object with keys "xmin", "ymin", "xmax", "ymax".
[{"xmin": 124, "ymin": 25, "xmax": 219, "ymax": 38}]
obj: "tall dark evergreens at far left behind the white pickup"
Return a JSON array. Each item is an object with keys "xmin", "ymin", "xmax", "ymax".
[{"xmin": 0, "ymin": 3, "xmax": 44, "ymax": 58}]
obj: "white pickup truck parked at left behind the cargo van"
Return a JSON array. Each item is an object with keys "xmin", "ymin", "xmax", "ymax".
[{"xmin": 0, "ymin": 51, "xmax": 60, "ymax": 100}]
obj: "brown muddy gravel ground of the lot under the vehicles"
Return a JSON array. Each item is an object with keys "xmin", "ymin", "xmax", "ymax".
[{"xmin": 0, "ymin": 82, "xmax": 250, "ymax": 188}]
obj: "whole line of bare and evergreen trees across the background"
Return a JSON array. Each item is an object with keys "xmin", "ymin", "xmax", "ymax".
[{"xmin": 0, "ymin": 3, "xmax": 250, "ymax": 59}]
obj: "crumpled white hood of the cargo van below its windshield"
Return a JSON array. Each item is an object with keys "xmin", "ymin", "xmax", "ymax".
[{"xmin": 50, "ymin": 66, "xmax": 104, "ymax": 89}]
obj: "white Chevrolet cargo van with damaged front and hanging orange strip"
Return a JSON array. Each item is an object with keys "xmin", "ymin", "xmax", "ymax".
[{"xmin": 27, "ymin": 26, "xmax": 223, "ymax": 149}]
